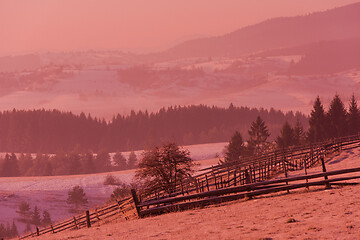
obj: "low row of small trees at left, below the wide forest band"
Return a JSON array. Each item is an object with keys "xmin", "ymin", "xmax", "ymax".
[{"xmin": 0, "ymin": 151, "xmax": 138, "ymax": 177}]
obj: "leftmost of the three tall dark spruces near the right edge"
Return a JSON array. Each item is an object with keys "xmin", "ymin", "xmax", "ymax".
[{"xmin": 308, "ymin": 96, "xmax": 326, "ymax": 142}]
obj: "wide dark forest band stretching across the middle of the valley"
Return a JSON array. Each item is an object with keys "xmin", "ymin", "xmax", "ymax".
[{"xmin": 0, "ymin": 104, "xmax": 308, "ymax": 153}]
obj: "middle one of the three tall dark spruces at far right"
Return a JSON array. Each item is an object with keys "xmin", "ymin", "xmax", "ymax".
[{"xmin": 327, "ymin": 94, "xmax": 347, "ymax": 137}]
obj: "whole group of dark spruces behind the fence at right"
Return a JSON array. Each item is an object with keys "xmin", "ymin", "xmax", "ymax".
[{"xmin": 224, "ymin": 95, "xmax": 360, "ymax": 162}]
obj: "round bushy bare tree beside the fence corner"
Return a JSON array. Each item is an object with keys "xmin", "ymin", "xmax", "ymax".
[{"xmin": 135, "ymin": 143, "xmax": 196, "ymax": 194}]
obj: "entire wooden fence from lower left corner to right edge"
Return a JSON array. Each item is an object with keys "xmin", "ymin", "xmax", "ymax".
[{"xmin": 20, "ymin": 135, "xmax": 360, "ymax": 239}]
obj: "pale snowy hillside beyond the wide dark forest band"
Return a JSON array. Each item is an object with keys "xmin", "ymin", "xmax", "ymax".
[{"xmin": 0, "ymin": 56, "xmax": 360, "ymax": 120}]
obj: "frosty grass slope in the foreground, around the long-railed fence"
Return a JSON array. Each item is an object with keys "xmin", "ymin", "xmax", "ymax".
[{"xmin": 35, "ymin": 148, "xmax": 360, "ymax": 240}]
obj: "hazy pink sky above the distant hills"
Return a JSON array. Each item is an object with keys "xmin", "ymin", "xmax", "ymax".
[{"xmin": 0, "ymin": 0, "xmax": 359, "ymax": 56}]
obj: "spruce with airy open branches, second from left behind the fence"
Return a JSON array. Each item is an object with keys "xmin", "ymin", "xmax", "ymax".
[{"xmin": 248, "ymin": 116, "xmax": 270, "ymax": 154}]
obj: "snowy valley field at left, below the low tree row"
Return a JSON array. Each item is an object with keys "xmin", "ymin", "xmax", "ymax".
[{"xmin": 0, "ymin": 143, "xmax": 226, "ymax": 233}]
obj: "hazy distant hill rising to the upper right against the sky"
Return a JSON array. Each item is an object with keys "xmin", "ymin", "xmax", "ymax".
[{"xmin": 148, "ymin": 2, "xmax": 360, "ymax": 60}]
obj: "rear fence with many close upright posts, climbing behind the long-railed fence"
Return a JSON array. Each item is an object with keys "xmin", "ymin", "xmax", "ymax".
[{"xmin": 138, "ymin": 135, "xmax": 360, "ymax": 215}]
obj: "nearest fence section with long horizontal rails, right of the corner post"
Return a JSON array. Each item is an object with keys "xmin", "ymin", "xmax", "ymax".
[{"xmin": 134, "ymin": 168, "xmax": 360, "ymax": 217}]
